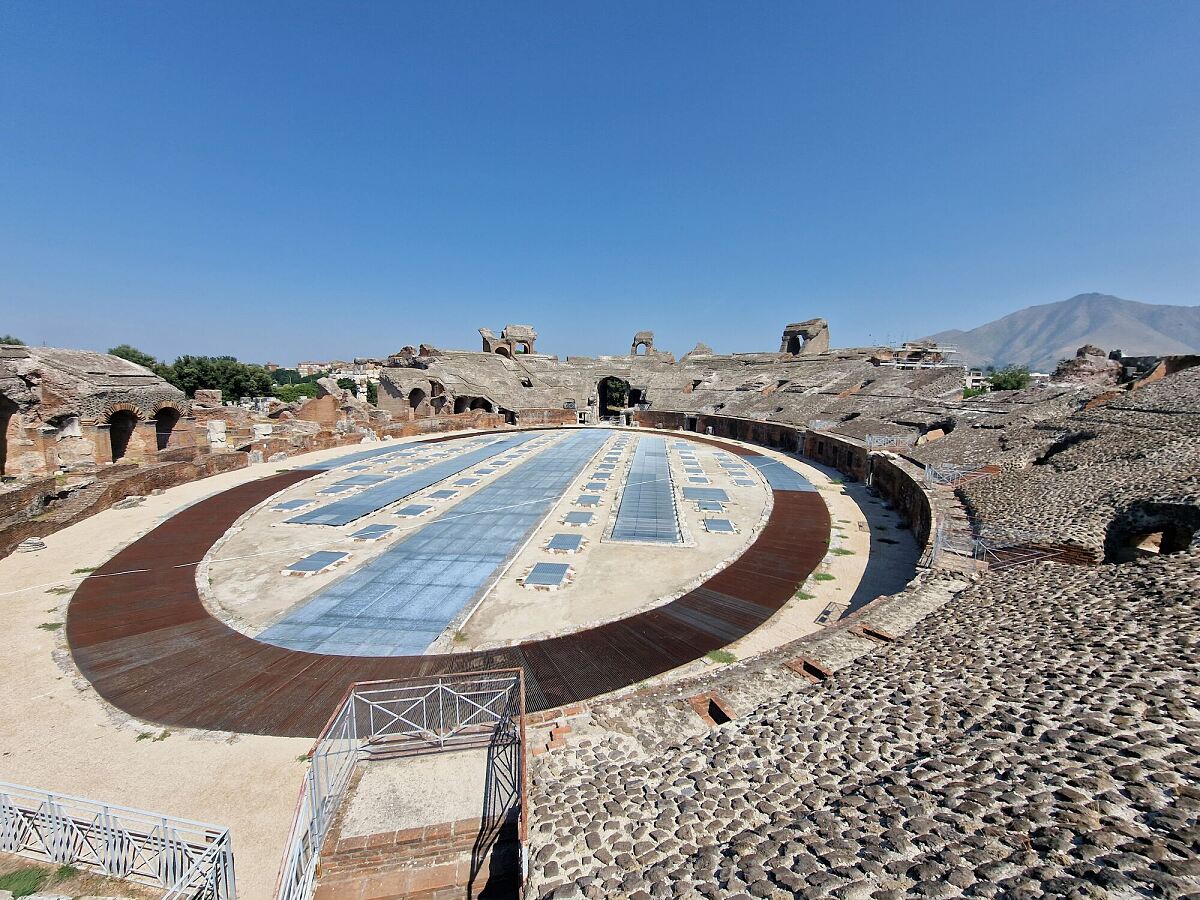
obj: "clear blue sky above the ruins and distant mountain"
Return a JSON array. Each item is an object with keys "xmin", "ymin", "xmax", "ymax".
[{"xmin": 0, "ymin": 0, "xmax": 1200, "ymax": 362}]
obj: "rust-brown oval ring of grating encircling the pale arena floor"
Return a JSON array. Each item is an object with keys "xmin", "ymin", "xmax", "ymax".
[{"xmin": 67, "ymin": 434, "xmax": 830, "ymax": 737}]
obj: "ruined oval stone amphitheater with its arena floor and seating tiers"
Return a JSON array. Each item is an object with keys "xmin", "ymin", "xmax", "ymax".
[{"xmin": 0, "ymin": 318, "xmax": 1200, "ymax": 900}]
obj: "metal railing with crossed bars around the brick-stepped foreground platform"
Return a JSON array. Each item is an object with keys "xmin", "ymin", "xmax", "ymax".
[{"xmin": 283, "ymin": 670, "xmax": 526, "ymax": 900}]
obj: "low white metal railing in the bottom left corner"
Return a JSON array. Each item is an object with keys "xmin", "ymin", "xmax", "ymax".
[{"xmin": 0, "ymin": 782, "xmax": 238, "ymax": 900}]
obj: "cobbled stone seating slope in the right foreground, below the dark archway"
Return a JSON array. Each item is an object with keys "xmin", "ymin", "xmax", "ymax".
[{"xmin": 530, "ymin": 546, "xmax": 1200, "ymax": 898}]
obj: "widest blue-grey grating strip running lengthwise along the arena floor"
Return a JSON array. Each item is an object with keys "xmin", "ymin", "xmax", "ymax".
[{"xmin": 258, "ymin": 431, "xmax": 611, "ymax": 656}]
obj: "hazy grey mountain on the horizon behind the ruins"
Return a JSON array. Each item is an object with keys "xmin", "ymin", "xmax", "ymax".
[{"xmin": 930, "ymin": 294, "xmax": 1200, "ymax": 372}]
